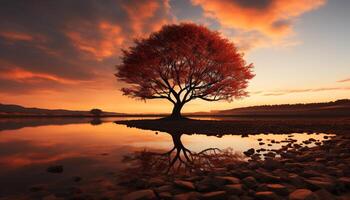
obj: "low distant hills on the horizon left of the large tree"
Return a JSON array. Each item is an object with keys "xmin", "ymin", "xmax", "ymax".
[{"xmin": 0, "ymin": 104, "xmax": 122, "ymax": 117}]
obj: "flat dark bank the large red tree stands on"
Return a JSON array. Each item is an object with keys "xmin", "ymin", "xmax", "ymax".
[{"xmin": 115, "ymin": 117, "xmax": 350, "ymax": 136}]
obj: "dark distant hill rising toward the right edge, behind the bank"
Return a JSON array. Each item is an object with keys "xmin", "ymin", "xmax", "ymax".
[{"xmin": 209, "ymin": 99, "xmax": 350, "ymax": 117}]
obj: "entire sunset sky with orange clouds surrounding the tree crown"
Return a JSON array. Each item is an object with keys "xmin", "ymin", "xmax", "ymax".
[{"xmin": 0, "ymin": 0, "xmax": 350, "ymax": 113}]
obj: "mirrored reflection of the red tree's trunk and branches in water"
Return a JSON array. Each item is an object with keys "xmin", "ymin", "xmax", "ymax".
[{"xmin": 124, "ymin": 133, "xmax": 242, "ymax": 174}]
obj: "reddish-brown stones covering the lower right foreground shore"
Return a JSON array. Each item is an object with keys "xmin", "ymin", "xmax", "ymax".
[{"xmin": 121, "ymin": 135, "xmax": 350, "ymax": 200}]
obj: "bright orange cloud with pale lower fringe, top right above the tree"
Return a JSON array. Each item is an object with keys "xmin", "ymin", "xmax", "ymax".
[{"xmin": 192, "ymin": 0, "xmax": 326, "ymax": 49}]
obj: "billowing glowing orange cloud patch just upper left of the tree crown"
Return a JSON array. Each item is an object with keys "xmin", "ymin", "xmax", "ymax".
[{"xmin": 64, "ymin": 1, "xmax": 170, "ymax": 61}]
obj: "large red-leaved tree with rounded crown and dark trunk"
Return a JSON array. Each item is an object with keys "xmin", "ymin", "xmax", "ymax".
[{"xmin": 115, "ymin": 23, "xmax": 254, "ymax": 119}]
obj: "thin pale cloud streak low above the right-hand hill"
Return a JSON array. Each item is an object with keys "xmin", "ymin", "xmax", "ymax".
[{"xmin": 263, "ymin": 87, "xmax": 350, "ymax": 96}]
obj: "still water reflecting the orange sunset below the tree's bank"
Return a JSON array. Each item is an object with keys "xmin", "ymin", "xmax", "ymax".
[{"xmin": 0, "ymin": 118, "xmax": 327, "ymax": 197}]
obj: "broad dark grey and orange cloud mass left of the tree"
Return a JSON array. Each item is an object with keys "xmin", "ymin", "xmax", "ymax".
[{"xmin": 0, "ymin": 0, "xmax": 172, "ymax": 94}]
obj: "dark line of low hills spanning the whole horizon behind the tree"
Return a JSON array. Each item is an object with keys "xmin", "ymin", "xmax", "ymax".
[{"xmin": 0, "ymin": 99, "xmax": 350, "ymax": 117}]
